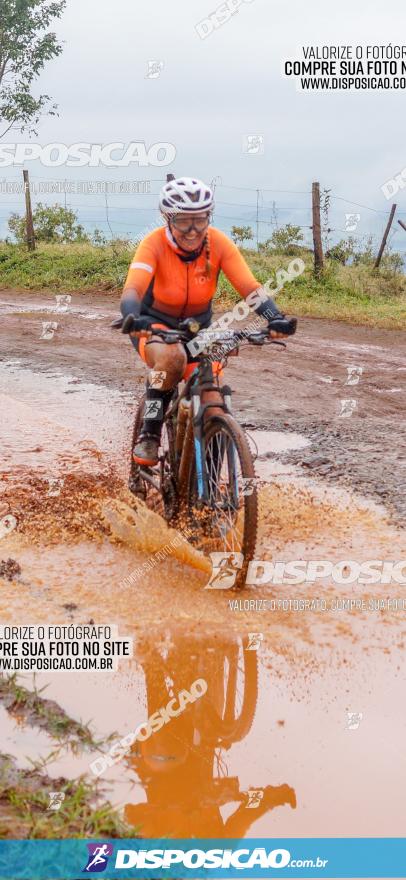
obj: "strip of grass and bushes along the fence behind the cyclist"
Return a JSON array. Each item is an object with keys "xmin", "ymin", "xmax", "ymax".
[{"xmin": 0, "ymin": 204, "xmax": 406, "ymax": 329}]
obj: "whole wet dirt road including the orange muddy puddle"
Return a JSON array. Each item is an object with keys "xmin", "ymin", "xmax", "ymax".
[{"xmin": 0, "ymin": 291, "xmax": 406, "ymax": 837}]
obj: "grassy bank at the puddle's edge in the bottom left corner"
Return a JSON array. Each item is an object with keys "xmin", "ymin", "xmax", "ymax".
[{"xmin": 0, "ymin": 675, "xmax": 134, "ymax": 840}]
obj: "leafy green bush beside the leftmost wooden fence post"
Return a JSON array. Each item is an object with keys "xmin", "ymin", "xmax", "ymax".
[{"xmin": 8, "ymin": 202, "xmax": 89, "ymax": 244}]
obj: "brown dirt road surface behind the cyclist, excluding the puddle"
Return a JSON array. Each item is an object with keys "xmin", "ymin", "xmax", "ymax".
[{"xmin": 0, "ymin": 291, "xmax": 406, "ymax": 520}]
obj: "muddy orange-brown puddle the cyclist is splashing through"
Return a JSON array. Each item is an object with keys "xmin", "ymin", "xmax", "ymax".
[{"xmin": 0, "ymin": 360, "xmax": 406, "ymax": 838}]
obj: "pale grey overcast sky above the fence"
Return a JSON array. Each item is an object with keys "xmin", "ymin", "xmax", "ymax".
[{"xmin": 0, "ymin": 0, "xmax": 406, "ymax": 244}]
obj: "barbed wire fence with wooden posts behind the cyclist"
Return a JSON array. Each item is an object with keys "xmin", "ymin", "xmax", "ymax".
[{"xmin": 0, "ymin": 174, "xmax": 406, "ymax": 270}]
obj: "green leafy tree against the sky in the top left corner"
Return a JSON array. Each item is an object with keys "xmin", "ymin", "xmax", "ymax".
[{"xmin": 0, "ymin": 0, "xmax": 66, "ymax": 137}]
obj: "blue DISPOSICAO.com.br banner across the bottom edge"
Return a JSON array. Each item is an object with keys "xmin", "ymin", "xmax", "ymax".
[{"xmin": 0, "ymin": 837, "xmax": 406, "ymax": 880}]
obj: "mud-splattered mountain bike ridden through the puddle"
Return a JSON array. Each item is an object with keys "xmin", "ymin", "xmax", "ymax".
[{"xmin": 112, "ymin": 316, "xmax": 285, "ymax": 588}]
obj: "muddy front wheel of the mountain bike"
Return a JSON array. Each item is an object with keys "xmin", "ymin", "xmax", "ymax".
[{"xmin": 185, "ymin": 414, "xmax": 258, "ymax": 587}]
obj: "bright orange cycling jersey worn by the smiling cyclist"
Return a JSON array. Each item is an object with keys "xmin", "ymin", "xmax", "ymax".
[{"xmin": 124, "ymin": 227, "xmax": 260, "ymax": 327}]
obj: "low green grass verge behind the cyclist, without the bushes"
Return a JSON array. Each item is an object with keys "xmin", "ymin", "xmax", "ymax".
[{"xmin": 0, "ymin": 242, "xmax": 406, "ymax": 329}]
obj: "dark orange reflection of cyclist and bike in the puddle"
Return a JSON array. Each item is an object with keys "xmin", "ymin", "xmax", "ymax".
[{"xmin": 119, "ymin": 634, "xmax": 296, "ymax": 838}]
